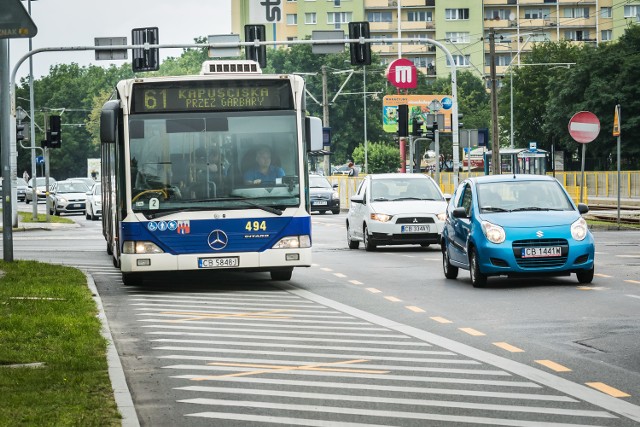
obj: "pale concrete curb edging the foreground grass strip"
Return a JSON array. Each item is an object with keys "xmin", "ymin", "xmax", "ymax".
[{"xmin": 84, "ymin": 272, "xmax": 140, "ymax": 427}]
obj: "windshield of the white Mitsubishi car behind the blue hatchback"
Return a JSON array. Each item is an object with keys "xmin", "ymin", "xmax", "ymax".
[{"xmin": 371, "ymin": 177, "xmax": 444, "ymax": 201}]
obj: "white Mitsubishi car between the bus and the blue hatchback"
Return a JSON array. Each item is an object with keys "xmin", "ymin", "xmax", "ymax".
[{"xmin": 347, "ymin": 173, "xmax": 447, "ymax": 251}]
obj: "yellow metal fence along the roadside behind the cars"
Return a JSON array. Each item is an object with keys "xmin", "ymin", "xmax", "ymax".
[{"xmin": 327, "ymin": 171, "xmax": 640, "ymax": 209}]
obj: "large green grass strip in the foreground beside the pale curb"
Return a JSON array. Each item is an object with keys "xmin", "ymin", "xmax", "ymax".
[{"xmin": 0, "ymin": 261, "xmax": 121, "ymax": 426}]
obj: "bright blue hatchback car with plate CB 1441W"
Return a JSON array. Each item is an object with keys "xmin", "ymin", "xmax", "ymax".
[{"xmin": 441, "ymin": 175, "xmax": 595, "ymax": 288}]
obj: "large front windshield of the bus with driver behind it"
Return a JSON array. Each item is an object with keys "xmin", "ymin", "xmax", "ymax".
[{"xmin": 128, "ymin": 110, "xmax": 300, "ymax": 214}]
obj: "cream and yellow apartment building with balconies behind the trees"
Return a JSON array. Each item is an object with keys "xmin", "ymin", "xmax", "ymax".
[{"xmin": 232, "ymin": 0, "xmax": 640, "ymax": 77}]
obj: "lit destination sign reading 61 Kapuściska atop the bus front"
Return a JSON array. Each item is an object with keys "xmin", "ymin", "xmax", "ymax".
[{"xmin": 131, "ymin": 80, "xmax": 293, "ymax": 114}]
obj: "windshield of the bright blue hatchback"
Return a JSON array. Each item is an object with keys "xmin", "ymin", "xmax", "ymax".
[{"xmin": 477, "ymin": 181, "xmax": 573, "ymax": 213}]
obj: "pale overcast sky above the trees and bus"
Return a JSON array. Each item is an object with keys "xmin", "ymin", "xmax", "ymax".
[{"xmin": 9, "ymin": 0, "xmax": 233, "ymax": 81}]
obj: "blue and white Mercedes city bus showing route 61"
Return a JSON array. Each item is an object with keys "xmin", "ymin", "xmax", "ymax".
[{"xmin": 100, "ymin": 61, "xmax": 322, "ymax": 285}]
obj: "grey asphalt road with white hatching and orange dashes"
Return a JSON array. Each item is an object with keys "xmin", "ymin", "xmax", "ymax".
[{"xmin": 5, "ymin": 206, "xmax": 640, "ymax": 426}]
